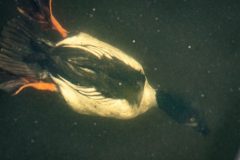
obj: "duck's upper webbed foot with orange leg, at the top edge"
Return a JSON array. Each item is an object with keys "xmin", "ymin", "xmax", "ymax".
[{"xmin": 16, "ymin": 0, "xmax": 68, "ymax": 38}]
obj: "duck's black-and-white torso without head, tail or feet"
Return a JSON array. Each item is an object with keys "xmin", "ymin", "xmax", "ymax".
[{"xmin": 51, "ymin": 33, "xmax": 156, "ymax": 119}]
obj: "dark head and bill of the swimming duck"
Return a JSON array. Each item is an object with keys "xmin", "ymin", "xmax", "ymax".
[{"xmin": 156, "ymin": 90, "xmax": 209, "ymax": 135}]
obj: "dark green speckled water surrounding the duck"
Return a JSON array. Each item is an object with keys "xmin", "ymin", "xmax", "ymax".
[{"xmin": 0, "ymin": 0, "xmax": 240, "ymax": 160}]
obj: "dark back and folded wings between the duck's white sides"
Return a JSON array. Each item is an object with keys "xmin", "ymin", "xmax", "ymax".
[{"xmin": 50, "ymin": 47, "xmax": 146, "ymax": 105}]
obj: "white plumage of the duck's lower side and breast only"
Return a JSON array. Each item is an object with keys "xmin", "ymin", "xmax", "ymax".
[{"xmin": 52, "ymin": 76, "xmax": 156, "ymax": 119}]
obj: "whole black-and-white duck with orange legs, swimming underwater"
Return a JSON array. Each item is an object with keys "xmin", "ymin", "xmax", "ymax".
[{"xmin": 0, "ymin": 0, "xmax": 208, "ymax": 134}]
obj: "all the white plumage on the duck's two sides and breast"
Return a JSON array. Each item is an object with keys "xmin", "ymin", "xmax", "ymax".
[{"xmin": 51, "ymin": 33, "xmax": 156, "ymax": 119}]
